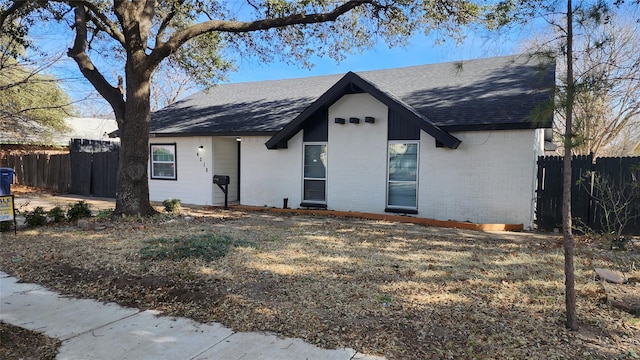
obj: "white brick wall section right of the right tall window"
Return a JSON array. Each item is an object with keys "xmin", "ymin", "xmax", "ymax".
[{"xmin": 419, "ymin": 130, "xmax": 541, "ymax": 228}]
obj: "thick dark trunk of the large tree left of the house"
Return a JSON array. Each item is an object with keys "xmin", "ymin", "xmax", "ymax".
[{"xmin": 115, "ymin": 51, "xmax": 156, "ymax": 216}]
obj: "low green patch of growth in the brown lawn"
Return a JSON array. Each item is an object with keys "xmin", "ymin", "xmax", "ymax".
[{"xmin": 138, "ymin": 234, "xmax": 254, "ymax": 260}]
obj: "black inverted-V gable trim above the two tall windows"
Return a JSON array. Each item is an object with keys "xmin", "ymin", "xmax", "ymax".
[{"xmin": 266, "ymin": 71, "xmax": 460, "ymax": 149}]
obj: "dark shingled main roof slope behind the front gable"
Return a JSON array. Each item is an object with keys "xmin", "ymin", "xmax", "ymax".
[{"xmin": 151, "ymin": 55, "xmax": 555, "ymax": 136}]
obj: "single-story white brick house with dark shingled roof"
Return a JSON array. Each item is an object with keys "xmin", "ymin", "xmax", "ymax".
[{"xmin": 149, "ymin": 55, "xmax": 555, "ymax": 228}]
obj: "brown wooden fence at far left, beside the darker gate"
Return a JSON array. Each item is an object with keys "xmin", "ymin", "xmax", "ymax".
[{"xmin": 2, "ymin": 154, "xmax": 71, "ymax": 193}]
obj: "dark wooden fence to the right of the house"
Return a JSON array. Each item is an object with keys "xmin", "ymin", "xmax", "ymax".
[{"xmin": 536, "ymin": 155, "xmax": 640, "ymax": 234}]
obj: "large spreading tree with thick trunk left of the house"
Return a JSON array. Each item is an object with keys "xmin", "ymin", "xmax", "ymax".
[{"xmin": 0, "ymin": 0, "xmax": 495, "ymax": 215}]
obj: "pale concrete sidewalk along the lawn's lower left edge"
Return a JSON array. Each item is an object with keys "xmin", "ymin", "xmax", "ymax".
[{"xmin": 0, "ymin": 271, "xmax": 383, "ymax": 360}]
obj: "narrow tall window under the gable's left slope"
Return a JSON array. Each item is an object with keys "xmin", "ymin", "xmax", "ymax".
[{"xmin": 303, "ymin": 144, "xmax": 327, "ymax": 203}]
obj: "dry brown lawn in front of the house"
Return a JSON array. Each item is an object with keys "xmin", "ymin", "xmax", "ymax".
[{"xmin": 0, "ymin": 200, "xmax": 640, "ymax": 359}]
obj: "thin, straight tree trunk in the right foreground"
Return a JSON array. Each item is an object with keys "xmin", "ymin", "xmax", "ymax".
[{"xmin": 562, "ymin": 0, "xmax": 578, "ymax": 330}]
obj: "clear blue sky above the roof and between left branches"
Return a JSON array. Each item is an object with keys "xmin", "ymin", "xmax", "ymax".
[{"xmin": 36, "ymin": 10, "xmax": 532, "ymax": 117}]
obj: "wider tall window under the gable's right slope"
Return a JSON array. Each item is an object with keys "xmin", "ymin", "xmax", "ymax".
[{"xmin": 387, "ymin": 142, "xmax": 418, "ymax": 209}]
